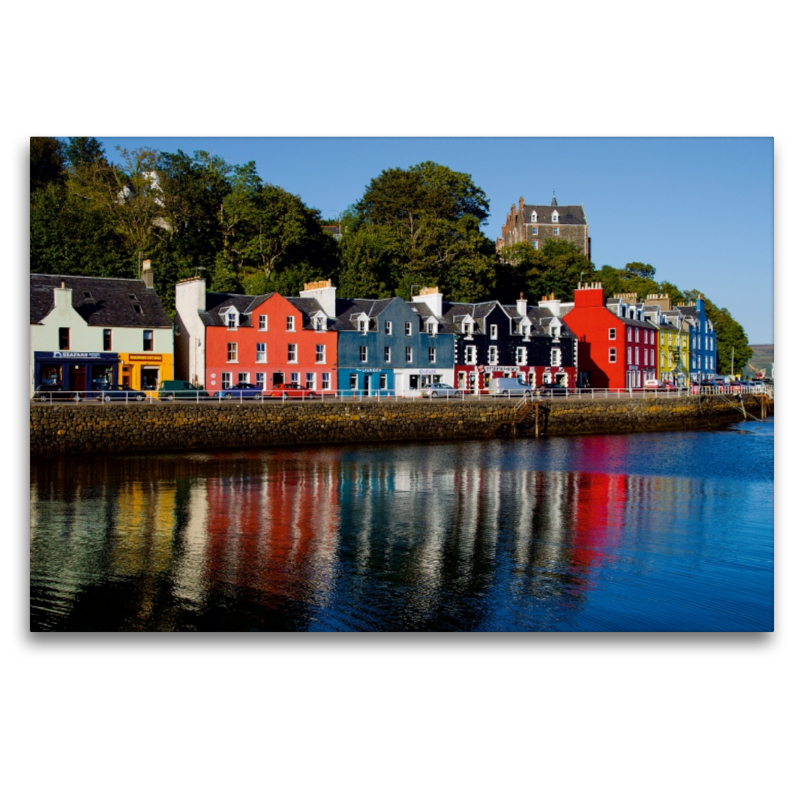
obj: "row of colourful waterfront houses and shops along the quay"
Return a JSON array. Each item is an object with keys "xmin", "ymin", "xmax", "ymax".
[{"xmin": 30, "ymin": 262, "xmax": 716, "ymax": 396}]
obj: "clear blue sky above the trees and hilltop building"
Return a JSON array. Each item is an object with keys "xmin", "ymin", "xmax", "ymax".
[{"xmin": 98, "ymin": 137, "xmax": 773, "ymax": 344}]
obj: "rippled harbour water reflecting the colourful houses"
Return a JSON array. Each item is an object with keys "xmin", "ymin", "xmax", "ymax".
[{"xmin": 31, "ymin": 420, "xmax": 774, "ymax": 631}]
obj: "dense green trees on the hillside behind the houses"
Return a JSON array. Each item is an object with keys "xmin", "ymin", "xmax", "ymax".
[{"xmin": 30, "ymin": 137, "xmax": 752, "ymax": 372}]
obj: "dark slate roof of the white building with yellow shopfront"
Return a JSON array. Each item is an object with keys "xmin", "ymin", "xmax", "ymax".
[{"xmin": 30, "ymin": 275, "xmax": 172, "ymax": 328}]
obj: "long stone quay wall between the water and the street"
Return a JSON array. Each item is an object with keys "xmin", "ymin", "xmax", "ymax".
[{"xmin": 30, "ymin": 396, "xmax": 772, "ymax": 456}]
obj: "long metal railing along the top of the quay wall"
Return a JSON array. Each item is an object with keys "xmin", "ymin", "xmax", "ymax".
[{"xmin": 31, "ymin": 385, "xmax": 774, "ymax": 408}]
